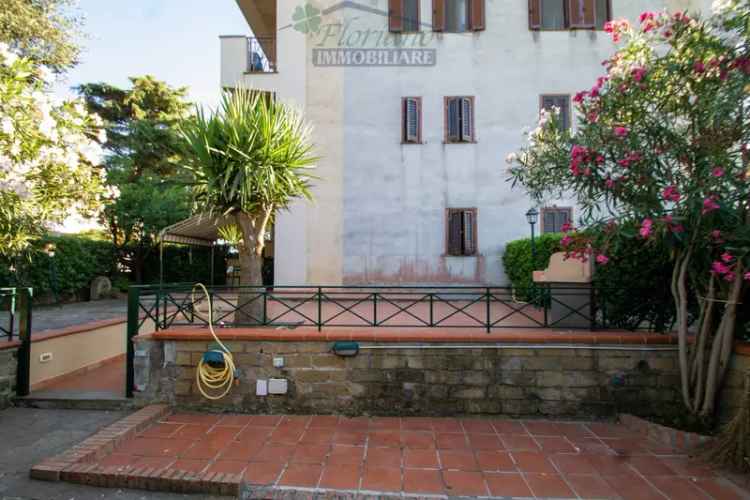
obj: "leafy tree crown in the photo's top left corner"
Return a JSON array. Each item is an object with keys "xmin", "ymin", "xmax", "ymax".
[{"xmin": 0, "ymin": 0, "xmax": 81, "ymax": 73}]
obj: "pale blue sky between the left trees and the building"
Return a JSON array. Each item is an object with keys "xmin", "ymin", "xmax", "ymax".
[{"xmin": 56, "ymin": 0, "xmax": 249, "ymax": 106}]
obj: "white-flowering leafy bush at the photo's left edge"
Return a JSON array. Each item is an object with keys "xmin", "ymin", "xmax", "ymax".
[{"xmin": 0, "ymin": 43, "xmax": 106, "ymax": 262}]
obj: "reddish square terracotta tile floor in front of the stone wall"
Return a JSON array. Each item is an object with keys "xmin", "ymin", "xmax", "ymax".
[{"xmin": 91, "ymin": 413, "xmax": 749, "ymax": 500}]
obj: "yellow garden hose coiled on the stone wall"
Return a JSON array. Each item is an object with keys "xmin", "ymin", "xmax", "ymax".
[{"xmin": 190, "ymin": 283, "xmax": 235, "ymax": 400}]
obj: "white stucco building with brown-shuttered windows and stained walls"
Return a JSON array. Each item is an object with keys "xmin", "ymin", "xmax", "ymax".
[{"xmin": 221, "ymin": 0, "xmax": 710, "ymax": 284}]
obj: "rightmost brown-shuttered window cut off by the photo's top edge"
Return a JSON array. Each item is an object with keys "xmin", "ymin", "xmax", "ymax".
[{"xmin": 528, "ymin": 0, "xmax": 612, "ymax": 30}]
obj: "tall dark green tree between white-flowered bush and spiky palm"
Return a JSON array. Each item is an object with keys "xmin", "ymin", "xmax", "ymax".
[{"xmin": 77, "ymin": 76, "xmax": 191, "ymax": 283}]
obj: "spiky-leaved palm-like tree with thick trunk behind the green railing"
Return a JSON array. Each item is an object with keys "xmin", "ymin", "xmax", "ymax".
[{"xmin": 180, "ymin": 88, "xmax": 317, "ymax": 323}]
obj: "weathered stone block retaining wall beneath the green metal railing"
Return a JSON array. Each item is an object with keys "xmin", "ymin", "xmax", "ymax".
[{"xmin": 135, "ymin": 337, "xmax": 679, "ymax": 418}]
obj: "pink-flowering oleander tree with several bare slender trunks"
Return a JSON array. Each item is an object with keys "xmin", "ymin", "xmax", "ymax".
[{"xmin": 509, "ymin": 4, "xmax": 750, "ymax": 426}]
